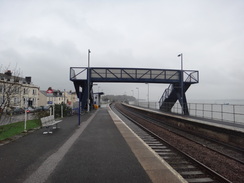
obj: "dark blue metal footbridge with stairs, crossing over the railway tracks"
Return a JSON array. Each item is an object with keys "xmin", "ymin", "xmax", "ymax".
[{"xmin": 70, "ymin": 67, "xmax": 199, "ymax": 115}]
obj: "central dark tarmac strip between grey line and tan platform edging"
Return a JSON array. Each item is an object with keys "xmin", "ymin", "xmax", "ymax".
[{"xmin": 46, "ymin": 109, "xmax": 151, "ymax": 183}]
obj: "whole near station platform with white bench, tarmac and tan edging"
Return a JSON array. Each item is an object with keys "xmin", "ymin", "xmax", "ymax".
[{"xmin": 0, "ymin": 108, "xmax": 184, "ymax": 183}]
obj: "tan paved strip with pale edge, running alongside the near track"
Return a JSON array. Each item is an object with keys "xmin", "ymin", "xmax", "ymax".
[{"xmin": 108, "ymin": 108, "xmax": 187, "ymax": 183}]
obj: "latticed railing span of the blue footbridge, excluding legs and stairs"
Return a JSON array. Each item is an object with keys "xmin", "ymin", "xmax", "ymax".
[{"xmin": 70, "ymin": 67, "xmax": 198, "ymax": 83}]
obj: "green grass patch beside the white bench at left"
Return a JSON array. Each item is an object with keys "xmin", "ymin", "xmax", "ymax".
[{"xmin": 0, "ymin": 119, "xmax": 40, "ymax": 140}]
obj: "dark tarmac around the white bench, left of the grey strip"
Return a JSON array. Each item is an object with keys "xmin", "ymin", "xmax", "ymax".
[{"xmin": 0, "ymin": 113, "xmax": 92, "ymax": 183}]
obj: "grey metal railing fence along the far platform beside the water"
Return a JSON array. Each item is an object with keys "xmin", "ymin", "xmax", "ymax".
[{"xmin": 137, "ymin": 102, "xmax": 244, "ymax": 124}]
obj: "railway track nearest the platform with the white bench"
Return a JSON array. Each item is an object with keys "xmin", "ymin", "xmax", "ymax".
[{"xmin": 112, "ymin": 104, "xmax": 236, "ymax": 183}]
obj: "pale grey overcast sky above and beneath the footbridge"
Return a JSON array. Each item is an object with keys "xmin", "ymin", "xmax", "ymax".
[{"xmin": 0, "ymin": 0, "xmax": 244, "ymax": 101}]
